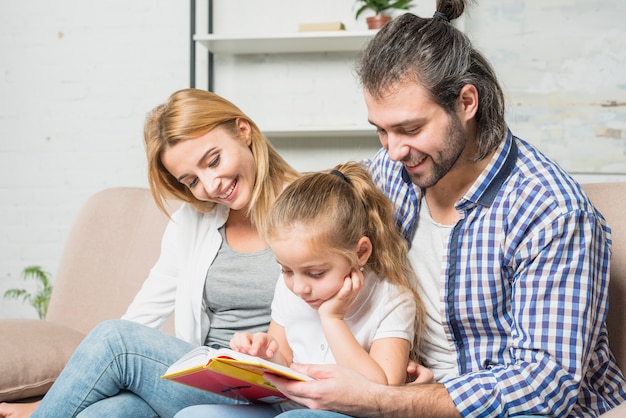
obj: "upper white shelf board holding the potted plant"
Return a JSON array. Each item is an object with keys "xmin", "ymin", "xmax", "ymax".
[{"xmin": 193, "ymin": 30, "xmax": 377, "ymax": 55}]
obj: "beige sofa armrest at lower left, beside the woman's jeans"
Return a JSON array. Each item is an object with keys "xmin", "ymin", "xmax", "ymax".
[{"xmin": 0, "ymin": 319, "xmax": 85, "ymax": 402}]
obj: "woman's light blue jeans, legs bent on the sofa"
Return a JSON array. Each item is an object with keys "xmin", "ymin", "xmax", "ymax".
[{"xmin": 32, "ymin": 320, "xmax": 239, "ymax": 418}]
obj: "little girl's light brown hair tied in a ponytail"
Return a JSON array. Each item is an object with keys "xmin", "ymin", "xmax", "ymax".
[{"xmin": 266, "ymin": 162, "xmax": 424, "ymax": 359}]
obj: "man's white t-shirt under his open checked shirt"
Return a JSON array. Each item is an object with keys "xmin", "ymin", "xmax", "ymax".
[{"xmin": 409, "ymin": 199, "xmax": 459, "ymax": 382}]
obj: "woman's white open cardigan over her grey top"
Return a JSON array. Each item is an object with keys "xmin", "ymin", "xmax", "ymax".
[{"xmin": 122, "ymin": 204, "xmax": 229, "ymax": 345}]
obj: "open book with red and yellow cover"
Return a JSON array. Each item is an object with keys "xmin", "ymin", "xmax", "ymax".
[{"xmin": 161, "ymin": 346, "xmax": 311, "ymax": 403}]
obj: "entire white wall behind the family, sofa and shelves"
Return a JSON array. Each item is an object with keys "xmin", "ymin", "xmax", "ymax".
[{"xmin": 0, "ymin": 0, "xmax": 626, "ymax": 317}]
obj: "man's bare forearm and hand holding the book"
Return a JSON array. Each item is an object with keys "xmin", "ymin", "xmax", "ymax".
[{"xmin": 265, "ymin": 364, "xmax": 460, "ymax": 418}]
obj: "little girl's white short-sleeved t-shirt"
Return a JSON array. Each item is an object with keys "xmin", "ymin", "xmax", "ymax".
[{"xmin": 272, "ymin": 272, "xmax": 415, "ymax": 364}]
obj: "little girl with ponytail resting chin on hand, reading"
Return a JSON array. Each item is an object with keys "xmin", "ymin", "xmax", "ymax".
[{"xmin": 176, "ymin": 163, "xmax": 423, "ymax": 418}]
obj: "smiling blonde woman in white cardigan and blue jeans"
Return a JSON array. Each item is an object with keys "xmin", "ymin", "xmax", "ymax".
[{"xmin": 0, "ymin": 89, "xmax": 298, "ymax": 418}]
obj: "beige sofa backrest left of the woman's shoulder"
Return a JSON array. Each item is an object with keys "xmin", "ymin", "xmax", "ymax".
[{"xmin": 46, "ymin": 188, "xmax": 178, "ymax": 334}]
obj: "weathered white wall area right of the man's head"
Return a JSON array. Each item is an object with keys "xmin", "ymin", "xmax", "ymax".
[{"xmin": 465, "ymin": 0, "xmax": 626, "ymax": 177}]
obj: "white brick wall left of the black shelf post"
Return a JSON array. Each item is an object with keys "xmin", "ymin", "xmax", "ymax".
[{"xmin": 0, "ymin": 0, "xmax": 189, "ymax": 317}]
